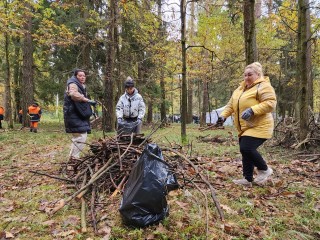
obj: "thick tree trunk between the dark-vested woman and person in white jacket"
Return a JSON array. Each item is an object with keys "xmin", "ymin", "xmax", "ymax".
[{"xmin": 103, "ymin": 0, "xmax": 117, "ymax": 132}]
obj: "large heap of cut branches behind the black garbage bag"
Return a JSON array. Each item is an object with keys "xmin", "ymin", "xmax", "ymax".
[{"xmin": 32, "ymin": 134, "xmax": 224, "ymax": 236}]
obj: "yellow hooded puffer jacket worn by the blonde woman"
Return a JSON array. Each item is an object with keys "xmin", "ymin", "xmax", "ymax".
[{"xmin": 221, "ymin": 77, "xmax": 277, "ymax": 139}]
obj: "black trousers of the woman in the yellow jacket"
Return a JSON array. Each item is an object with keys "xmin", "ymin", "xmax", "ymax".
[{"xmin": 239, "ymin": 136, "xmax": 268, "ymax": 182}]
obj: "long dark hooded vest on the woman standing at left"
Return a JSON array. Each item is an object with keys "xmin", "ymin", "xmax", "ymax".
[{"xmin": 63, "ymin": 76, "xmax": 91, "ymax": 133}]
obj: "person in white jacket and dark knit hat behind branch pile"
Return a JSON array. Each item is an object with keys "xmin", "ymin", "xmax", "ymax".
[{"xmin": 116, "ymin": 77, "xmax": 146, "ymax": 134}]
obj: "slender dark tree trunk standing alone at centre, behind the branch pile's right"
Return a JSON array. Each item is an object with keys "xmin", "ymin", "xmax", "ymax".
[{"xmin": 180, "ymin": 0, "xmax": 188, "ymax": 143}]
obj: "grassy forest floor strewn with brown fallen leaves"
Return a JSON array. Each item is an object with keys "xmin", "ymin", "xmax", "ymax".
[{"xmin": 0, "ymin": 121, "xmax": 320, "ymax": 240}]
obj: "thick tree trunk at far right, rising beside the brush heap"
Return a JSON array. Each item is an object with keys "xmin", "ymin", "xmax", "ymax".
[{"xmin": 297, "ymin": 0, "xmax": 312, "ymax": 141}]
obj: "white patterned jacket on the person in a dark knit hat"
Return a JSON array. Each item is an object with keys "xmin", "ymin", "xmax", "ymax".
[{"xmin": 116, "ymin": 89, "xmax": 146, "ymax": 119}]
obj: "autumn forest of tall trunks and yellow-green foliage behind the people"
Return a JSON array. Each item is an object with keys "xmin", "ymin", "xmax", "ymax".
[{"xmin": 0, "ymin": 0, "xmax": 320, "ymax": 142}]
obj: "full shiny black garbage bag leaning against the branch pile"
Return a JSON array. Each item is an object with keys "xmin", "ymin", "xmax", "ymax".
[{"xmin": 119, "ymin": 144, "xmax": 179, "ymax": 227}]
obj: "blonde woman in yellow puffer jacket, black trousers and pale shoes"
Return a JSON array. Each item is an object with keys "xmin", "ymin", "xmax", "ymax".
[{"xmin": 217, "ymin": 62, "xmax": 277, "ymax": 187}]
